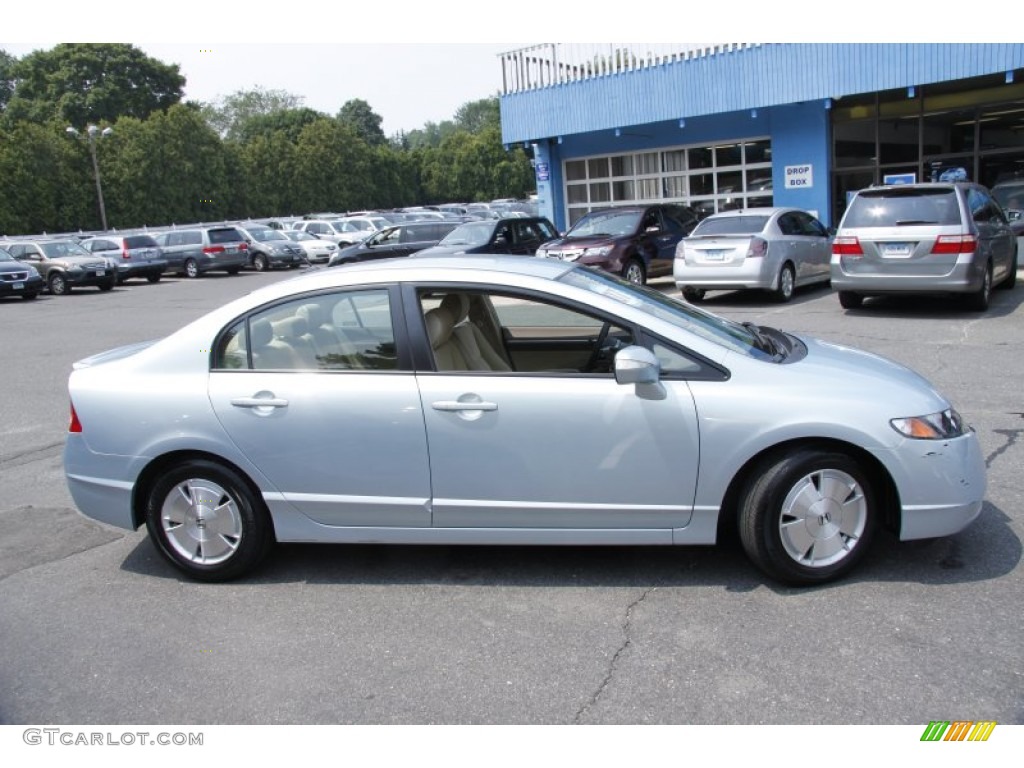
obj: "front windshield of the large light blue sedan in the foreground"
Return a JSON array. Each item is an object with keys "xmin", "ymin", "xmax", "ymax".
[{"xmin": 558, "ymin": 267, "xmax": 771, "ymax": 359}]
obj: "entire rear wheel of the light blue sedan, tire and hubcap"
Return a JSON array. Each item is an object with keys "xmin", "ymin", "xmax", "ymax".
[{"xmin": 145, "ymin": 459, "xmax": 274, "ymax": 582}]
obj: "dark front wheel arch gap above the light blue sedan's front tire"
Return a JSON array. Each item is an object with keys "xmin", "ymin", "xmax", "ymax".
[{"xmin": 718, "ymin": 437, "xmax": 901, "ymax": 538}]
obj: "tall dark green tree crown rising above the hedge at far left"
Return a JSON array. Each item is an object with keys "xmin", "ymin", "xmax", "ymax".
[{"xmin": 4, "ymin": 43, "xmax": 185, "ymax": 127}]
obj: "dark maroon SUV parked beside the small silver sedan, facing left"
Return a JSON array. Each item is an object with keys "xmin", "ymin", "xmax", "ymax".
[{"xmin": 537, "ymin": 205, "xmax": 697, "ymax": 284}]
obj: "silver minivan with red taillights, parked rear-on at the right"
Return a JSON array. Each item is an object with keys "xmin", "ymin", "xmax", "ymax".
[{"xmin": 831, "ymin": 182, "xmax": 1017, "ymax": 311}]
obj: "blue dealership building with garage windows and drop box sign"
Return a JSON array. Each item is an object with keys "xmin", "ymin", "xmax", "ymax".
[{"xmin": 500, "ymin": 43, "xmax": 1024, "ymax": 229}]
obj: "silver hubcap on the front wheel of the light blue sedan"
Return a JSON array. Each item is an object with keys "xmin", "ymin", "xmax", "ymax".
[{"xmin": 778, "ymin": 469, "xmax": 867, "ymax": 568}]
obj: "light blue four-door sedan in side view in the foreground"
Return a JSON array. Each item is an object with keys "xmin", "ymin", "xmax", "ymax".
[{"xmin": 65, "ymin": 256, "xmax": 985, "ymax": 585}]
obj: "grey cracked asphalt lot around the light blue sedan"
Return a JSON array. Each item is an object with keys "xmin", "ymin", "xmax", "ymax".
[{"xmin": 0, "ymin": 272, "xmax": 1024, "ymax": 724}]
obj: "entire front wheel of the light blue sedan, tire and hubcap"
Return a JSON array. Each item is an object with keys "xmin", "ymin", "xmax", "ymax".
[{"xmin": 739, "ymin": 449, "xmax": 880, "ymax": 586}]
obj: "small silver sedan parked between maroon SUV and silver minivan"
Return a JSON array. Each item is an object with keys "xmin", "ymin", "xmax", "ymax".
[{"xmin": 673, "ymin": 208, "xmax": 831, "ymax": 301}]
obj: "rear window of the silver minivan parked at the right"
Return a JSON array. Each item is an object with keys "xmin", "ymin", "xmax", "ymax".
[{"xmin": 843, "ymin": 187, "xmax": 961, "ymax": 227}]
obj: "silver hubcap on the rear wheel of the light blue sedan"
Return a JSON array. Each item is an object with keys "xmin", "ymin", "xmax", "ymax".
[{"xmin": 160, "ymin": 479, "xmax": 242, "ymax": 565}]
